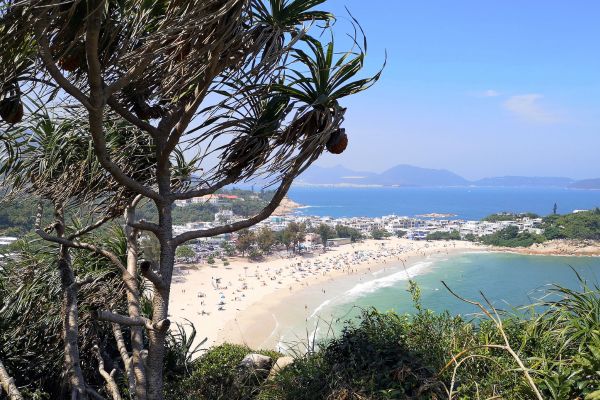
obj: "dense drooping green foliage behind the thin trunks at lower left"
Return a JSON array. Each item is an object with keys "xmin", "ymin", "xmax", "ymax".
[{"xmin": 0, "ymin": 228, "xmax": 126, "ymax": 399}]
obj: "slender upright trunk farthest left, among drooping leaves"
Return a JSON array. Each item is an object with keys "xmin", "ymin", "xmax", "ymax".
[{"xmin": 54, "ymin": 204, "xmax": 88, "ymax": 400}]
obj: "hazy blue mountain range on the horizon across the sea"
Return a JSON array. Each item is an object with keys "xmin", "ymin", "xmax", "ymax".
[{"xmin": 296, "ymin": 164, "xmax": 600, "ymax": 189}]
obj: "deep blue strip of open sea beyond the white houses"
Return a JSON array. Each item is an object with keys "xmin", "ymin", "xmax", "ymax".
[{"xmin": 289, "ymin": 187, "xmax": 600, "ymax": 220}]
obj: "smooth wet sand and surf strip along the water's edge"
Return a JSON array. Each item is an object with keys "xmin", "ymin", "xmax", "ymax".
[{"xmin": 217, "ymin": 246, "xmax": 476, "ymax": 351}]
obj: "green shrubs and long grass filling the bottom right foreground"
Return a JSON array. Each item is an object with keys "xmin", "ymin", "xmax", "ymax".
[{"xmin": 161, "ymin": 282, "xmax": 600, "ymax": 400}]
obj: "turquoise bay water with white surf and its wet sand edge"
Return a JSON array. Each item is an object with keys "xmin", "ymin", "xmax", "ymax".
[{"xmin": 274, "ymin": 252, "xmax": 600, "ymax": 353}]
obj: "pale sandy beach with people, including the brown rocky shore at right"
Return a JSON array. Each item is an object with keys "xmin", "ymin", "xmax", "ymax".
[{"xmin": 170, "ymin": 238, "xmax": 600, "ymax": 349}]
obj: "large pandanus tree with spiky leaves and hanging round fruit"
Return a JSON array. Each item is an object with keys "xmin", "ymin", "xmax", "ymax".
[{"xmin": 0, "ymin": 0, "xmax": 381, "ymax": 394}]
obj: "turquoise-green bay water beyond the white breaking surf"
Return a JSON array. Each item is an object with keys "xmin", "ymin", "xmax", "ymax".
[{"xmin": 330, "ymin": 253, "xmax": 600, "ymax": 315}]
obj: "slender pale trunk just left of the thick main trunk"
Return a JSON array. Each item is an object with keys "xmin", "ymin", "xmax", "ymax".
[{"xmin": 124, "ymin": 205, "xmax": 148, "ymax": 400}]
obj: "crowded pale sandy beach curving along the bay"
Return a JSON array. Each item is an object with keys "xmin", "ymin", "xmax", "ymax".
[{"xmin": 170, "ymin": 238, "xmax": 487, "ymax": 347}]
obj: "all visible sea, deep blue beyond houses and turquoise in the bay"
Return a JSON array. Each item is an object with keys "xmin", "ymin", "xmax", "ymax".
[{"xmin": 277, "ymin": 187, "xmax": 600, "ymax": 351}]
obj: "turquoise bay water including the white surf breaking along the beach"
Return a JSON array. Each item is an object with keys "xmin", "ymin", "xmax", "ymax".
[{"xmin": 279, "ymin": 253, "xmax": 600, "ymax": 349}]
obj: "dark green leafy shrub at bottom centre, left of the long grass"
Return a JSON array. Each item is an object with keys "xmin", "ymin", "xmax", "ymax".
[{"xmin": 259, "ymin": 309, "xmax": 443, "ymax": 400}]
